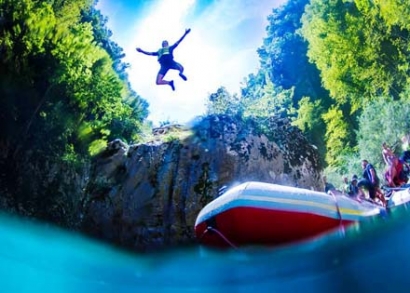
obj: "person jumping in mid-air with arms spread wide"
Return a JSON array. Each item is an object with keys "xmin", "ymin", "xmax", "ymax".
[{"xmin": 137, "ymin": 29, "xmax": 191, "ymax": 91}]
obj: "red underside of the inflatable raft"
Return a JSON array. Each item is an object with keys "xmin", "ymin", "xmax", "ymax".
[{"xmin": 195, "ymin": 207, "xmax": 354, "ymax": 247}]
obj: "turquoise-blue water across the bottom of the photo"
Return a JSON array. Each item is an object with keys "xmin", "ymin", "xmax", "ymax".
[{"xmin": 0, "ymin": 206, "xmax": 410, "ymax": 293}]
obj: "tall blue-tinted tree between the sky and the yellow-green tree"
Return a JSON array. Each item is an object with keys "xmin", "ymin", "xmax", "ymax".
[{"xmin": 258, "ymin": 0, "xmax": 329, "ymax": 106}]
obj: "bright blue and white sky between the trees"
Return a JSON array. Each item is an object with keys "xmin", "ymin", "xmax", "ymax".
[{"xmin": 97, "ymin": 0, "xmax": 287, "ymax": 125}]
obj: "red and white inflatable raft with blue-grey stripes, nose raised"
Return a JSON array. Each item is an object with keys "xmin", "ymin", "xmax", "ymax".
[{"xmin": 195, "ymin": 182, "xmax": 385, "ymax": 247}]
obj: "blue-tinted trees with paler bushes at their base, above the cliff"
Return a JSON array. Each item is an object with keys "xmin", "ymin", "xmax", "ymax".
[{"xmin": 242, "ymin": 0, "xmax": 333, "ymax": 163}]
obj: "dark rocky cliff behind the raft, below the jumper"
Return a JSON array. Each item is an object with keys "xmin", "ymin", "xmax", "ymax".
[{"xmin": 82, "ymin": 116, "xmax": 321, "ymax": 251}]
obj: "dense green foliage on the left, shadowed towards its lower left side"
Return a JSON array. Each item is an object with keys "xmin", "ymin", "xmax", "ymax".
[{"xmin": 0, "ymin": 0, "xmax": 148, "ymax": 224}]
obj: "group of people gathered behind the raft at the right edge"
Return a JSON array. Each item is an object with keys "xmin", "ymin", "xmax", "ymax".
[{"xmin": 323, "ymin": 139, "xmax": 410, "ymax": 206}]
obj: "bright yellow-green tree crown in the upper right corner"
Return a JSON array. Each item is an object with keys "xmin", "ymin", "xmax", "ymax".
[{"xmin": 301, "ymin": 0, "xmax": 410, "ymax": 105}]
